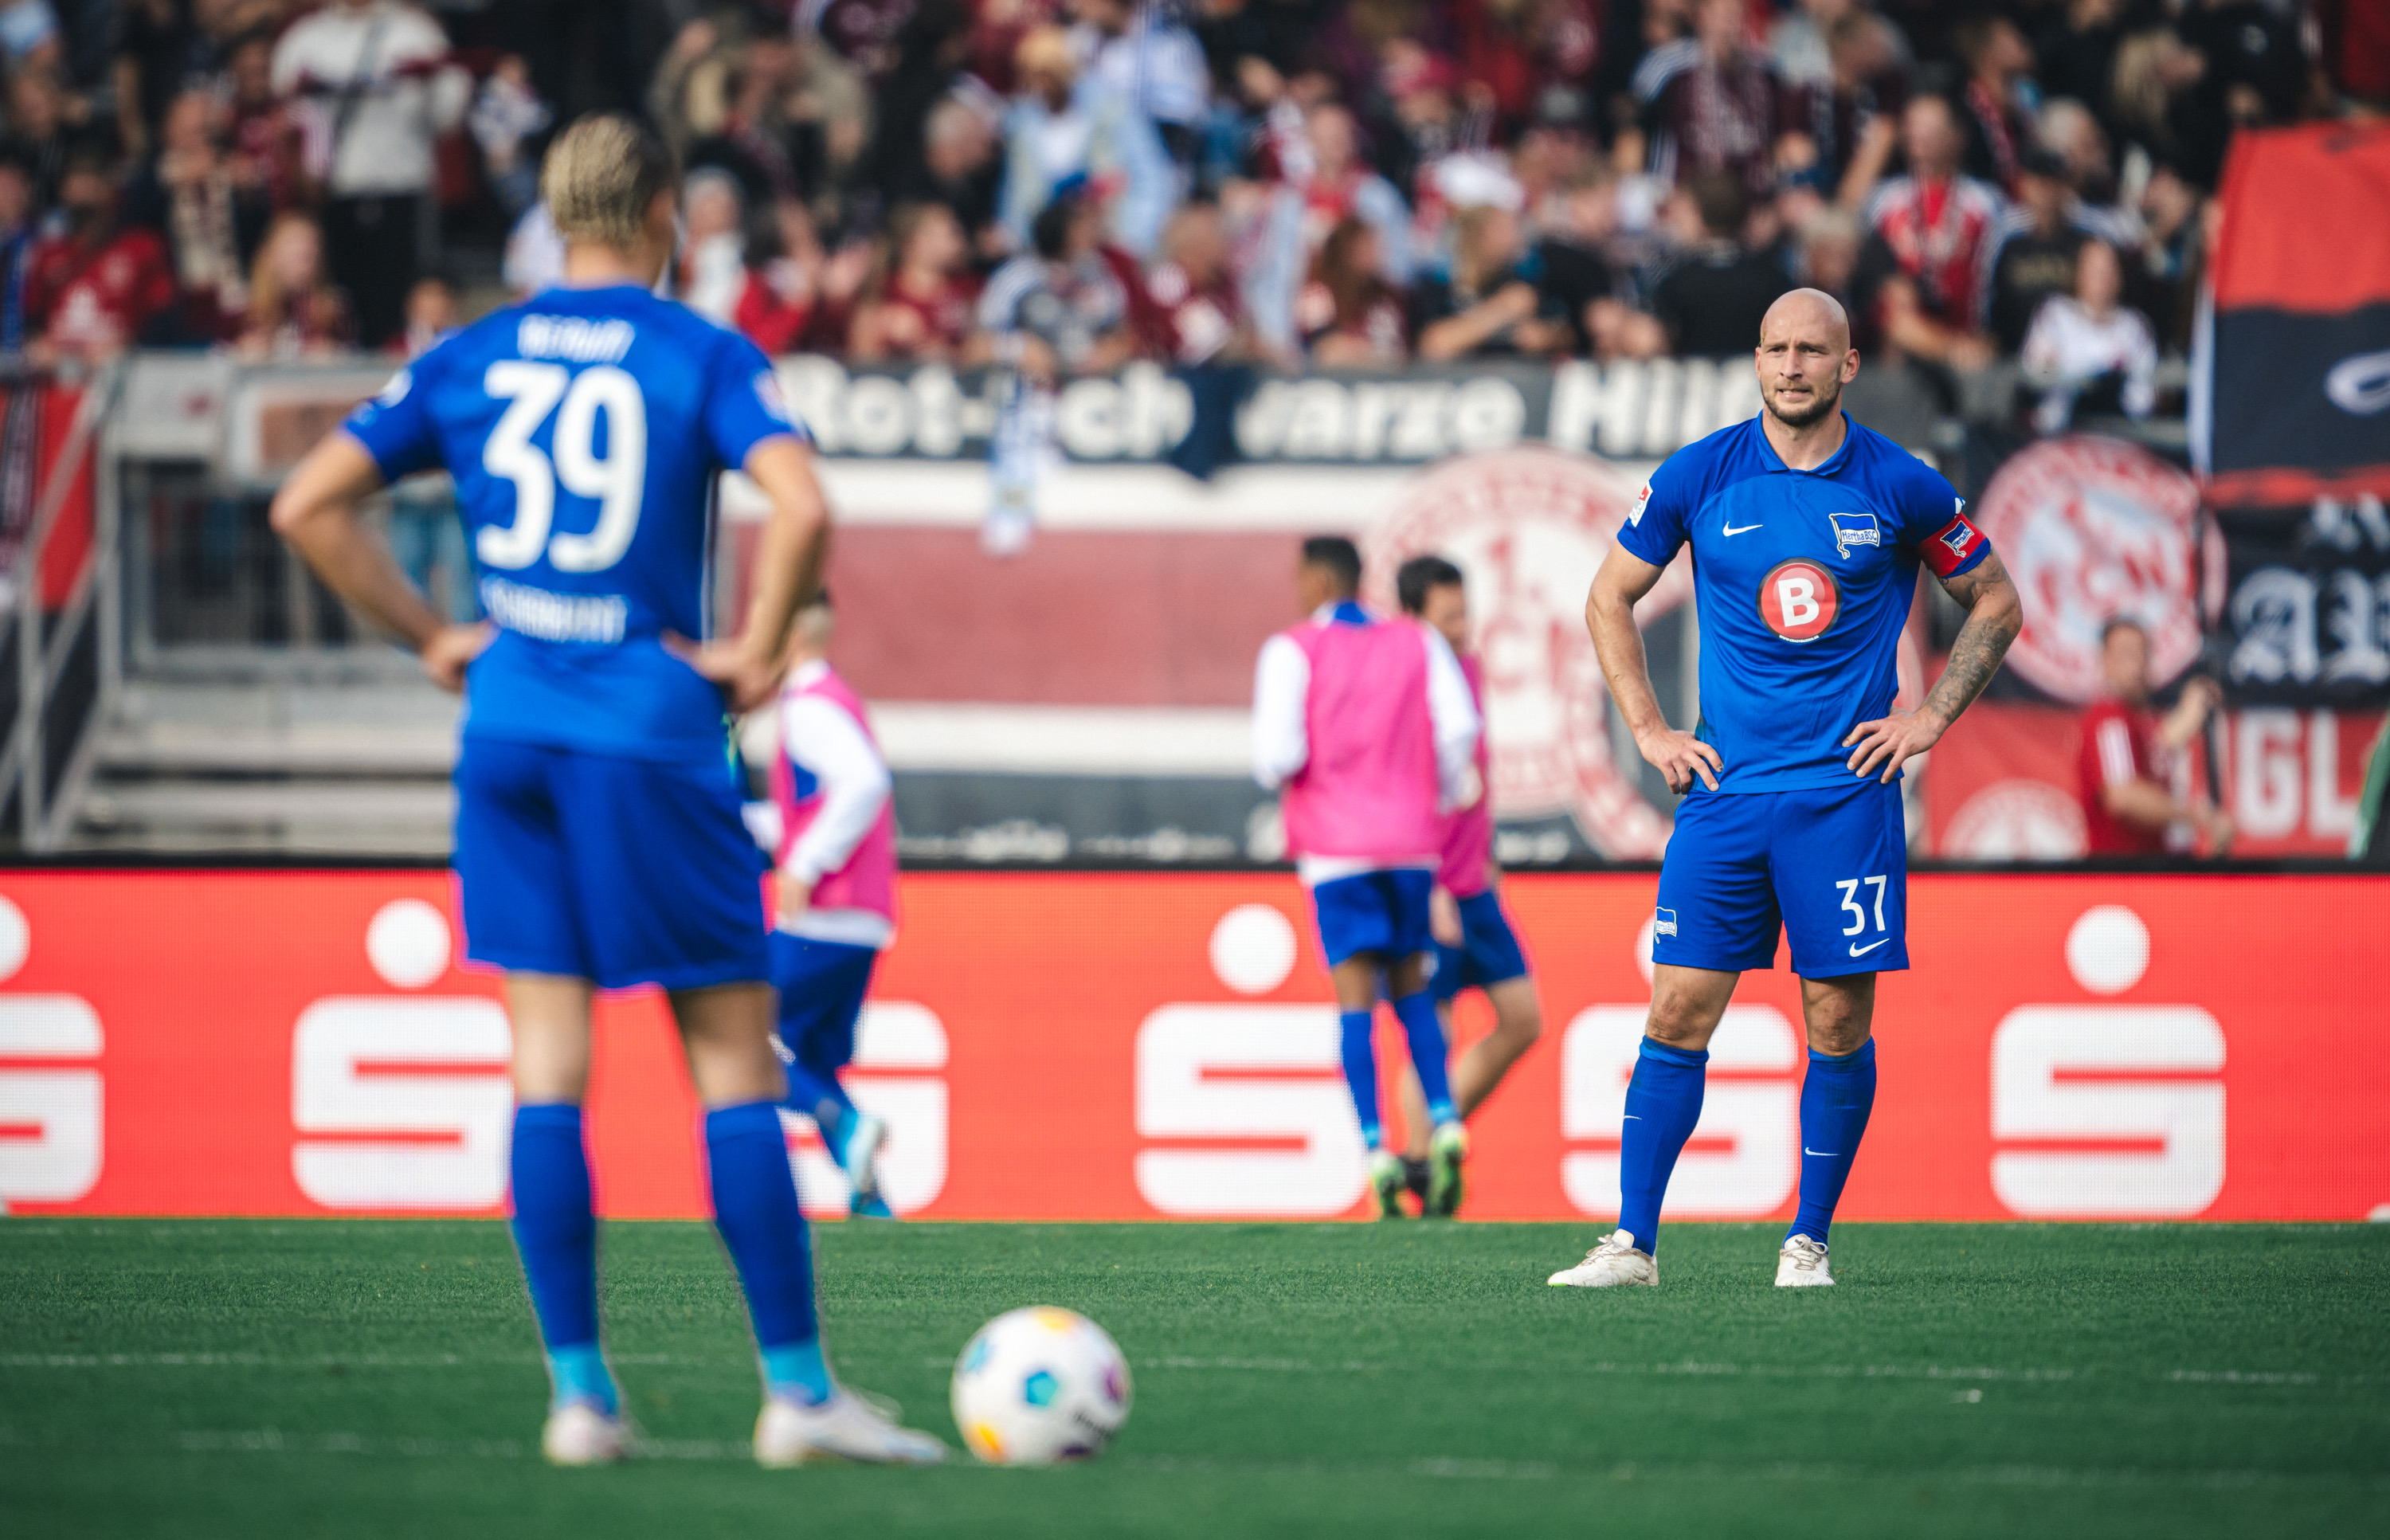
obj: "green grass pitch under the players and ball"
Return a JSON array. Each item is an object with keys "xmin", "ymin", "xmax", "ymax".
[{"xmin": 0, "ymin": 1217, "xmax": 2390, "ymax": 1540}]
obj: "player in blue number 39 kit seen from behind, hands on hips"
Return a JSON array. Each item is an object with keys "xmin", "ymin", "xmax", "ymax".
[{"xmin": 272, "ymin": 117, "xmax": 944, "ymax": 1466}]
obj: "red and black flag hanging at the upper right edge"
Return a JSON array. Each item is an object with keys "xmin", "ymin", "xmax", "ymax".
[{"xmin": 2192, "ymin": 122, "xmax": 2390, "ymax": 504}]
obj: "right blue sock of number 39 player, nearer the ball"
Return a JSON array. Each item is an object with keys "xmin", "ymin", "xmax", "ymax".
[{"xmin": 705, "ymin": 1103, "xmax": 829, "ymax": 1401}]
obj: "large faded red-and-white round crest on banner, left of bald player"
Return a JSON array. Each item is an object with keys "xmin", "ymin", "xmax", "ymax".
[{"xmin": 1365, "ymin": 447, "xmax": 1692, "ymax": 859}]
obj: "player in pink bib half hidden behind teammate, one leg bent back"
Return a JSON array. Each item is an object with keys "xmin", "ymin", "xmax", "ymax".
[{"xmin": 1393, "ymin": 557, "xmax": 1544, "ymax": 1213}]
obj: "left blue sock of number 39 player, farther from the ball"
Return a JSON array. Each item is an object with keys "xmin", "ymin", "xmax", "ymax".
[{"xmin": 509, "ymin": 1103, "xmax": 619, "ymax": 1416}]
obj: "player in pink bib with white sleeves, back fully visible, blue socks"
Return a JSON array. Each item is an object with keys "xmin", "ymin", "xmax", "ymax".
[{"xmin": 1252, "ymin": 535, "xmax": 1479, "ymax": 1220}]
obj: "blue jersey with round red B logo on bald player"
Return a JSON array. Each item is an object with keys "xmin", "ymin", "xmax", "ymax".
[{"xmin": 1618, "ymin": 416, "xmax": 1991, "ymax": 792}]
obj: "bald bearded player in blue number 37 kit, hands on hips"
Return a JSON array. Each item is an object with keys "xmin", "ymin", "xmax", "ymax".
[{"xmin": 1551, "ymin": 289, "xmax": 2022, "ymax": 1289}]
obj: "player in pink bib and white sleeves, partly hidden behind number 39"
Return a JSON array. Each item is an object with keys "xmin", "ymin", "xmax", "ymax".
[{"xmin": 770, "ymin": 590, "xmax": 896, "ymax": 1220}]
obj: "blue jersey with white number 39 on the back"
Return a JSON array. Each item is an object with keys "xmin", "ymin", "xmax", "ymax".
[{"xmin": 347, "ymin": 284, "xmax": 801, "ymax": 760}]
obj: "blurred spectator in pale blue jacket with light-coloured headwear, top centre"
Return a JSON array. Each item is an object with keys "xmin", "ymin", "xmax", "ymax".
[{"xmin": 1004, "ymin": 26, "xmax": 1178, "ymax": 256}]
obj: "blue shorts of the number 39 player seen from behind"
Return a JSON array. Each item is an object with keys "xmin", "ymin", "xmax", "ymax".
[{"xmin": 456, "ymin": 736, "xmax": 770, "ymax": 990}]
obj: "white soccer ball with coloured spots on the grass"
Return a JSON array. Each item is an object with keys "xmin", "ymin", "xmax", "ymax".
[{"xmin": 954, "ymin": 1306, "xmax": 1130, "ymax": 1466}]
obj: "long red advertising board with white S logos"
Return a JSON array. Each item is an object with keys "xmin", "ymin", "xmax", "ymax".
[{"xmin": 0, "ymin": 871, "xmax": 2390, "ymax": 1220}]
